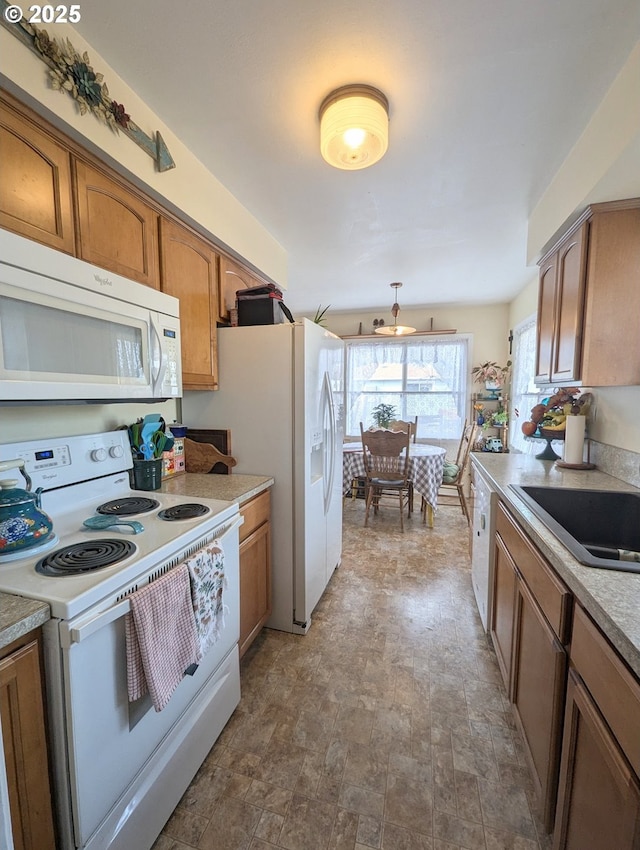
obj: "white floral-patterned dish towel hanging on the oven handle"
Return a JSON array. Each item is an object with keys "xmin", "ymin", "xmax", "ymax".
[{"xmin": 185, "ymin": 540, "xmax": 227, "ymax": 655}]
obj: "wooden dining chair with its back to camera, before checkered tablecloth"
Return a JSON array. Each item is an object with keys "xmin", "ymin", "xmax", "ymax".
[{"xmin": 360, "ymin": 423, "xmax": 411, "ymax": 531}]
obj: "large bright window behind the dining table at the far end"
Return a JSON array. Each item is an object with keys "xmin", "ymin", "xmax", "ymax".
[{"xmin": 345, "ymin": 336, "xmax": 468, "ymax": 440}]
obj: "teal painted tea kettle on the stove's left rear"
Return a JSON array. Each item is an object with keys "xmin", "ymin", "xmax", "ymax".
[{"xmin": 0, "ymin": 458, "xmax": 53, "ymax": 560}]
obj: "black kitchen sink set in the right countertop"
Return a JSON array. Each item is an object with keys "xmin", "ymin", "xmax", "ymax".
[{"xmin": 510, "ymin": 484, "xmax": 640, "ymax": 573}]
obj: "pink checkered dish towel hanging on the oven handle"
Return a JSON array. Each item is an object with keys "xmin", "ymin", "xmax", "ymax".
[{"xmin": 125, "ymin": 564, "xmax": 201, "ymax": 711}]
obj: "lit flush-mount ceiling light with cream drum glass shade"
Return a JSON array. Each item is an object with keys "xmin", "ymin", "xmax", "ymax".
[{"xmin": 319, "ymin": 84, "xmax": 389, "ymax": 171}]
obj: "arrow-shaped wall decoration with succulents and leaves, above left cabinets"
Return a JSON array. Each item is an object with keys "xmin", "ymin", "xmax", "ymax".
[{"xmin": 0, "ymin": 0, "xmax": 176, "ymax": 171}]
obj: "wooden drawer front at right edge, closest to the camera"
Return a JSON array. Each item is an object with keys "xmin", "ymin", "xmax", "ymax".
[{"xmin": 569, "ymin": 605, "xmax": 640, "ymax": 776}]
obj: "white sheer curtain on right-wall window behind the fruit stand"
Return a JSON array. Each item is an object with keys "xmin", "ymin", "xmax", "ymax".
[{"xmin": 509, "ymin": 315, "xmax": 544, "ymax": 454}]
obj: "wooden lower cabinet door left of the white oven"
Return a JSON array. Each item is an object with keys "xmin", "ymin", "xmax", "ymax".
[{"xmin": 0, "ymin": 641, "xmax": 55, "ymax": 850}]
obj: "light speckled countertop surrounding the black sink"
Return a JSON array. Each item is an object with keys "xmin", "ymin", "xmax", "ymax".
[{"xmin": 471, "ymin": 452, "xmax": 640, "ymax": 678}]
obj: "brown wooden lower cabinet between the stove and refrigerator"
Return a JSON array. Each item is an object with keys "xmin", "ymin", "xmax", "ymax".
[{"xmin": 239, "ymin": 490, "xmax": 271, "ymax": 658}]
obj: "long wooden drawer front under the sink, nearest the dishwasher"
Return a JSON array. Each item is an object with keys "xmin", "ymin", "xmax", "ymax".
[{"xmin": 496, "ymin": 504, "xmax": 571, "ymax": 644}]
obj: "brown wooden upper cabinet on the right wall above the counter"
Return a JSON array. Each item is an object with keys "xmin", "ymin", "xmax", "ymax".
[{"xmin": 536, "ymin": 198, "xmax": 640, "ymax": 386}]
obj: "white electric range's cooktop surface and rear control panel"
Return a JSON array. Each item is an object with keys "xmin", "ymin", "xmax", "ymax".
[{"xmin": 0, "ymin": 431, "xmax": 238, "ymax": 620}]
